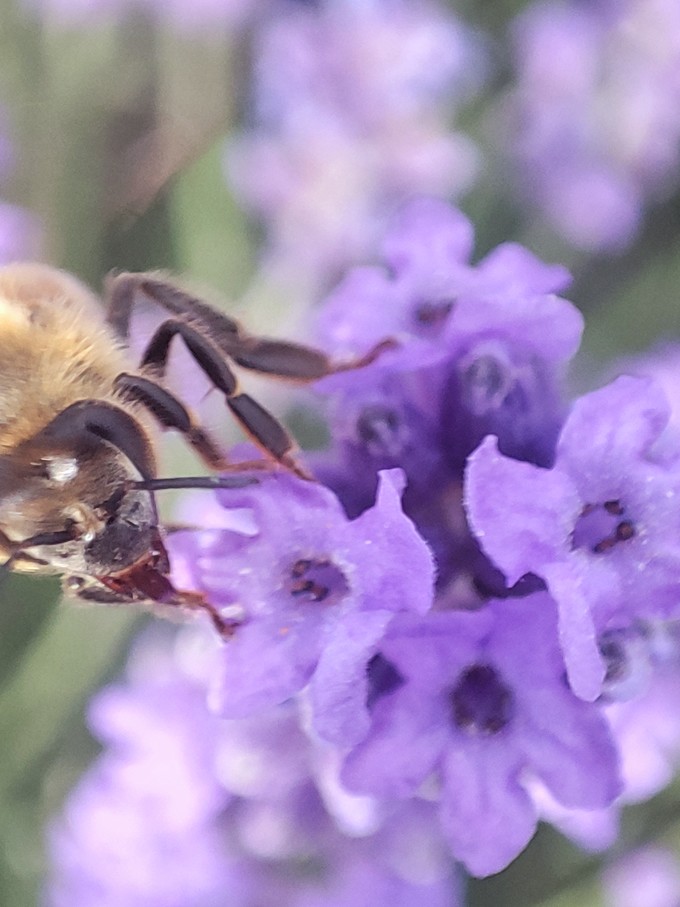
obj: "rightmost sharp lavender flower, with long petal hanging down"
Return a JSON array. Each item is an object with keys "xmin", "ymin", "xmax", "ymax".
[{"xmin": 466, "ymin": 377, "xmax": 680, "ymax": 699}]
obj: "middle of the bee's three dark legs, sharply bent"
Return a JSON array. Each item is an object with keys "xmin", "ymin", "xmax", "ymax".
[{"xmin": 140, "ymin": 319, "xmax": 312, "ymax": 479}]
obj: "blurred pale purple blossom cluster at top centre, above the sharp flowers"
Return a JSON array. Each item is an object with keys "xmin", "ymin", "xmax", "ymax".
[{"xmin": 226, "ymin": 0, "xmax": 482, "ymax": 286}]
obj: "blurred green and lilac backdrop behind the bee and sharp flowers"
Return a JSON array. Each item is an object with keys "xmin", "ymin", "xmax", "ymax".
[{"xmin": 0, "ymin": 0, "xmax": 680, "ymax": 907}]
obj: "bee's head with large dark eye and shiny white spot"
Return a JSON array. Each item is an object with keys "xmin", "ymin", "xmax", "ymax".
[{"xmin": 0, "ymin": 401, "xmax": 162, "ymax": 576}]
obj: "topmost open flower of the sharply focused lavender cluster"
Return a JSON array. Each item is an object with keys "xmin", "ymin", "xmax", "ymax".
[{"xmin": 318, "ymin": 198, "xmax": 582, "ymax": 358}]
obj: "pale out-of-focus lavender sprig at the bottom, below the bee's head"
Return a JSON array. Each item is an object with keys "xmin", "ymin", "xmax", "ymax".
[{"xmin": 45, "ymin": 630, "xmax": 461, "ymax": 907}]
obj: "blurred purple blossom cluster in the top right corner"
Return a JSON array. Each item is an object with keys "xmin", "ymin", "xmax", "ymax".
[{"xmin": 505, "ymin": 0, "xmax": 680, "ymax": 251}]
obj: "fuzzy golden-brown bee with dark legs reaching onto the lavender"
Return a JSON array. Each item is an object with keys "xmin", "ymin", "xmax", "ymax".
[{"xmin": 0, "ymin": 263, "xmax": 391, "ymax": 637}]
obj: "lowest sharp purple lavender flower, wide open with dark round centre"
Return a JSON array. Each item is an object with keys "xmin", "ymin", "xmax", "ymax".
[{"xmin": 343, "ymin": 594, "xmax": 620, "ymax": 875}]
